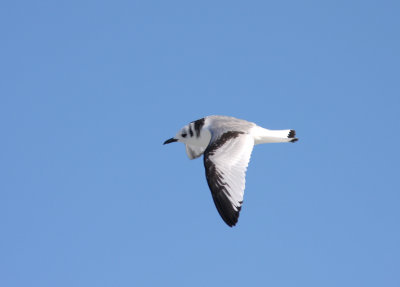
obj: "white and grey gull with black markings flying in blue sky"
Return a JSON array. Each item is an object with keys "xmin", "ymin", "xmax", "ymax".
[{"xmin": 164, "ymin": 116, "xmax": 298, "ymax": 227}]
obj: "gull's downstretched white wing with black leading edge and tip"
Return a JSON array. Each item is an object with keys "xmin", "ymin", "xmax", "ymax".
[{"xmin": 204, "ymin": 131, "xmax": 254, "ymax": 227}]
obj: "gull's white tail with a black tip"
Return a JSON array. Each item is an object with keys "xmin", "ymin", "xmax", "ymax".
[{"xmin": 252, "ymin": 126, "xmax": 298, "ymax": 144}]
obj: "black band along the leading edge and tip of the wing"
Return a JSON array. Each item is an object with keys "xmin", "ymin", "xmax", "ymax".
[{"xmin": 204, "ymin": 132, "xmax": 243, "ymax": 227}]
